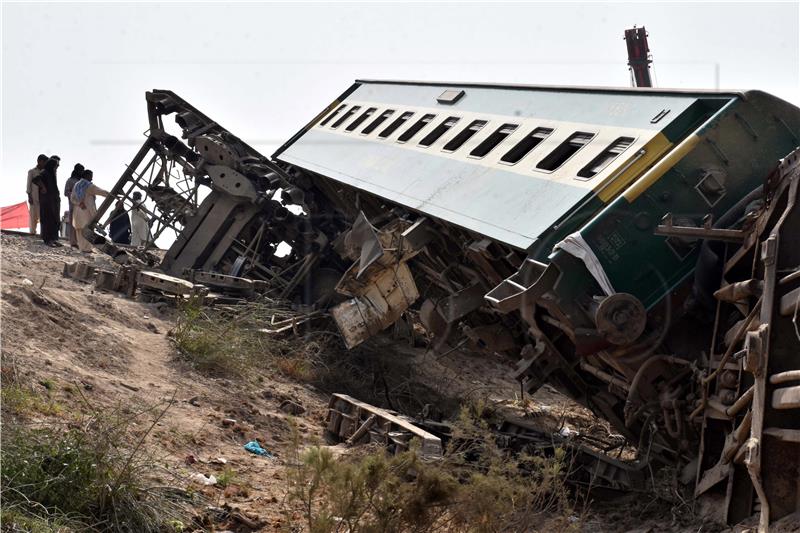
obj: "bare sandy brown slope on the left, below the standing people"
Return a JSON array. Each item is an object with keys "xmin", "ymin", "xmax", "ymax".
[{"xmin": 2, "ymin": 235, "xmax": 327, "ymax": 530}]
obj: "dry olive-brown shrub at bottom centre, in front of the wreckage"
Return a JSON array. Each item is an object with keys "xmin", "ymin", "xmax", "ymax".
[{"xmin": 287, "ymin": 409, "xmax": 579, "ymax": 533}]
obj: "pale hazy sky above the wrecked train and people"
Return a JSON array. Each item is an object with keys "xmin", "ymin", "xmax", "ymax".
[{"xmin": 0, "ymin": 1, "xmax": 800, "ymax": 214}]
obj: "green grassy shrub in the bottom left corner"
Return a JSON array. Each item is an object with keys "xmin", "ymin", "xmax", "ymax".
[{"xmin": 0, "ymin": 400, "xmax": 192, "ymax": 532}]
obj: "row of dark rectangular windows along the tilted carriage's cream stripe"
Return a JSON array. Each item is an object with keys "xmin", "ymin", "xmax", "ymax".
[{"xmin": 320, "ymin": 104, "xmax": 634, "ymax": 179}]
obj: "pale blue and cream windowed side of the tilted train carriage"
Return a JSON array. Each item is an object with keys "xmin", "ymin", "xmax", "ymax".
[{"xmin": 273, "ymin": 80, "xmax": 742, "ymax": 249}]
